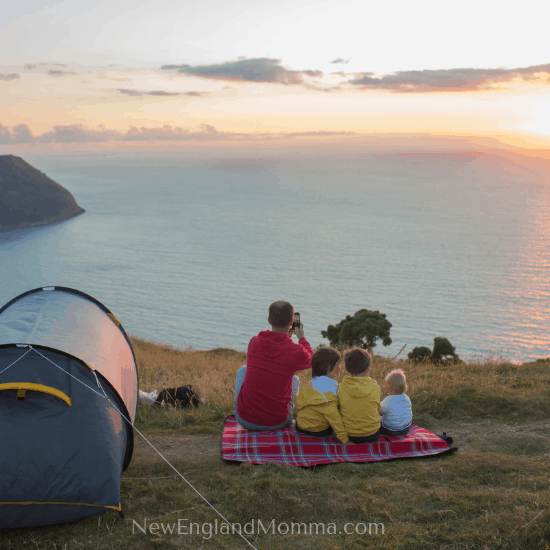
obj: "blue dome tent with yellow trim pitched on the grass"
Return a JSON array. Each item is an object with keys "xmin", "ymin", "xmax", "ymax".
[{"xmin": 0, "ymin": 287, "xmax": 138, "ymax": 528}]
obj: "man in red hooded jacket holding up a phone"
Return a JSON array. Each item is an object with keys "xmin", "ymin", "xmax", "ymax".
[{"xmin": 235, "ymin": 301, "xmax": 313, "ymax": 431}]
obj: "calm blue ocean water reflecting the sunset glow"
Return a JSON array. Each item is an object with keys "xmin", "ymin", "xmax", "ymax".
[{"xmin": 0, "ymin": 153, "xmax": 550, "ymax": 360}]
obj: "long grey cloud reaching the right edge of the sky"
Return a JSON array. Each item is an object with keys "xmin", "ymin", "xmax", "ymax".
[{"xmin": 347, "ymin": 63, "xmax": 550, "ymax": 93}]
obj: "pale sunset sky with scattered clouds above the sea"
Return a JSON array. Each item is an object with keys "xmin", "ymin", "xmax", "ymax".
[{"xmin": 0, "ymin": 0, "xmax": 550, "ymax": 154}]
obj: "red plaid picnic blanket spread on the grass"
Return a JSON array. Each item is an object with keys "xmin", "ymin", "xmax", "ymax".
[{"xmin": 222, "ymin": 416, "xmax": 456, "ymax": 466}]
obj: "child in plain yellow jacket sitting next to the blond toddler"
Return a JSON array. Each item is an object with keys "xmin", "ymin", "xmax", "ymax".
[{"xmin": 338, "ymin": 348, "xmax": 380, "ymax": 443}]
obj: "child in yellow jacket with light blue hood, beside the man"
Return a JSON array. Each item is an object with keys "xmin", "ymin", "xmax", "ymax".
[{"xmin": 296, "ymin": 348, "xmax": 348, "ymax": 445}]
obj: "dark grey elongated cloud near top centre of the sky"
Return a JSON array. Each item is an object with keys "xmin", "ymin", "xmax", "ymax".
[{"xmin": 161, "ymin": 57, "xmax": 323, "ymax": 85}]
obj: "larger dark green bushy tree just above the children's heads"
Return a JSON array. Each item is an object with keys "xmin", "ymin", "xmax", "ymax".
[{"xmin": 321, "ymin": 309, "xmax": 392, "ymax": 349}]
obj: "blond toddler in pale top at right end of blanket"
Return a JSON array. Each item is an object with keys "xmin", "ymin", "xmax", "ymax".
[{"xmin": 380, "ymin": 369, "xmax": 412, "ymax": 435}]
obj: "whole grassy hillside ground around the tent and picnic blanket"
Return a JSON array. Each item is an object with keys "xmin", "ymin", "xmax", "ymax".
[{"xmin": 0, "ymin": 339, "xmax": 550, "ymax": 550}]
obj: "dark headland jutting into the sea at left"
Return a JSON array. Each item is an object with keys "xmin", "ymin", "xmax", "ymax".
[{"xmin": 0, "ymin": 155, "xmax": 85, "ymax": 231}]
